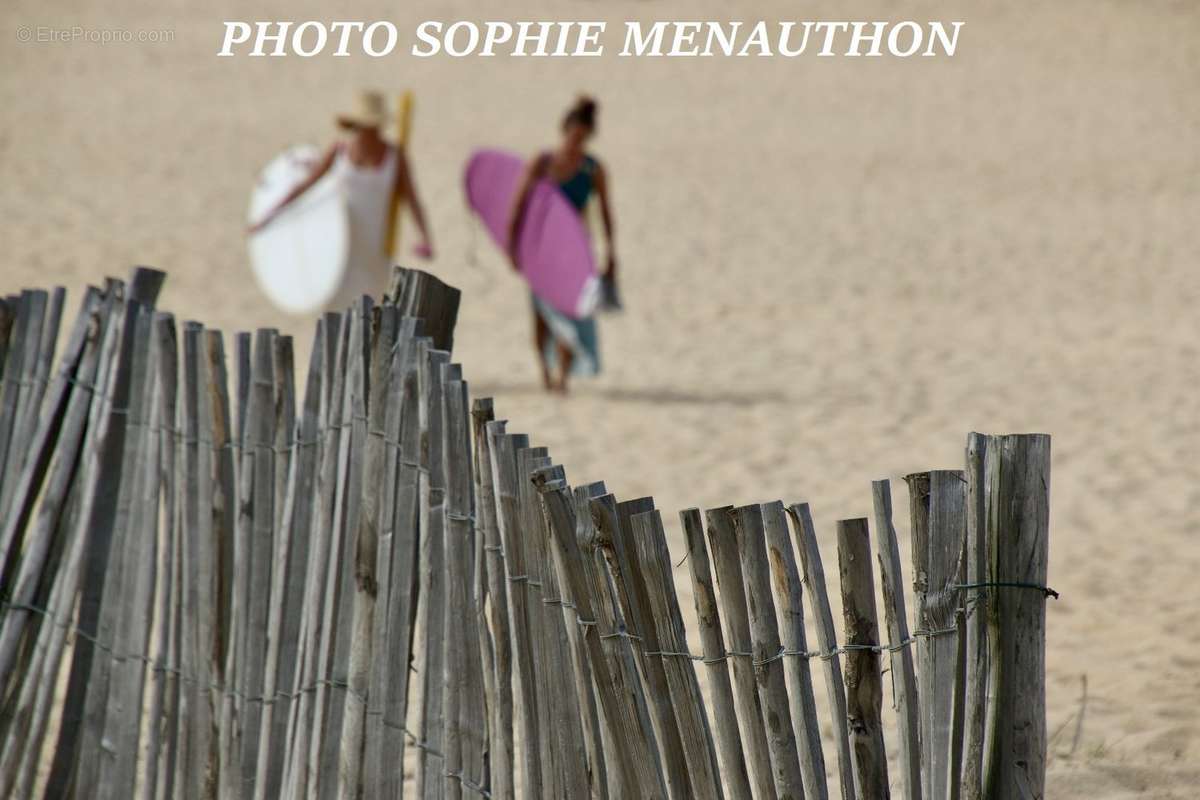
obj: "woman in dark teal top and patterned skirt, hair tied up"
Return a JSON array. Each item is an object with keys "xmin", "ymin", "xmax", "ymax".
[{"xmin": 506, "ymin": 97, "xmax": 620, "ymax": 393}]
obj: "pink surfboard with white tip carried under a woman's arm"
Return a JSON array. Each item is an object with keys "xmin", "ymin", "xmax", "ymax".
[{"xmin": 466, "ymin": 150, "xmax": 600, "ymax": 319}]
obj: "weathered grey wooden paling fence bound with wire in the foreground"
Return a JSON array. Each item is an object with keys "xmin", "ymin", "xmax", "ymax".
[{"xmin": 0, "ymin": 269, "xmax": 1052, "ymax": 800}]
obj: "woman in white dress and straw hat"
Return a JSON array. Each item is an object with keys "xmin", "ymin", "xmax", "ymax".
[{"xmin": 250, "ymin": 91, "xmax": 433, "ymax": 311}]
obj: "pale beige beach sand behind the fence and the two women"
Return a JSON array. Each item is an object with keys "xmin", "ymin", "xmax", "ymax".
[{"xmin": 0, "ymin": 0, "xmax": 1200, "ymax": 799}]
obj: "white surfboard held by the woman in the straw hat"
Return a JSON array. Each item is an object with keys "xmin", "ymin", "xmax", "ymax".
[{"xmin": 250, "ymin": 145, "xmax": 349, "ymax": 314}]
